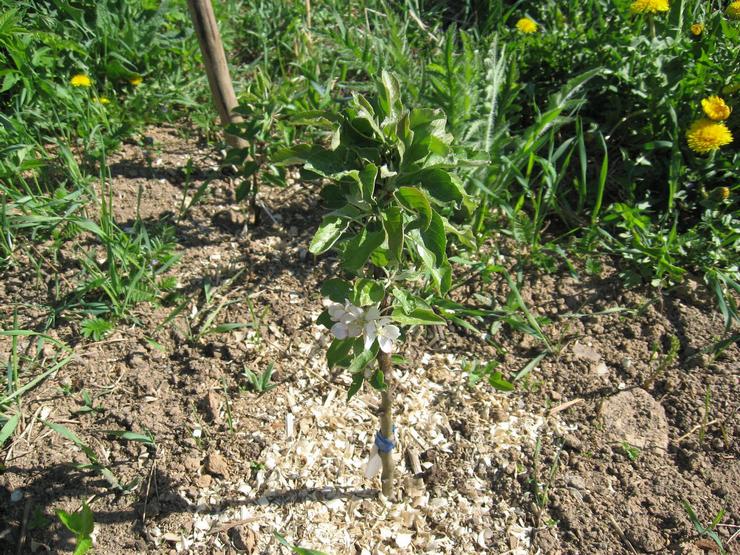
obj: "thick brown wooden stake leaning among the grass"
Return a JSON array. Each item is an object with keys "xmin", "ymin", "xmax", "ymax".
[{"xmin": 188, "ymin": 0, "xmax": 248, "ymax": 148}]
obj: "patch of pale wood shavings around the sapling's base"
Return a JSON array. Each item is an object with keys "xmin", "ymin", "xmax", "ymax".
[{"xmin": 166, "ymin": 355, "xmax": 544, "ymax": 555}]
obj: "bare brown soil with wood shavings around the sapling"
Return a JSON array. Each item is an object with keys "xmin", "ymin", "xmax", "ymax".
[{"xmin": 0, "ymin": 128, "xmax": 740, "ymax": 554}]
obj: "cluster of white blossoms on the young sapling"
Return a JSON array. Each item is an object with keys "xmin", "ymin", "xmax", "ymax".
[{"xmin": 324, "ymin": 299, "xmax": 401, "ymax": 353}]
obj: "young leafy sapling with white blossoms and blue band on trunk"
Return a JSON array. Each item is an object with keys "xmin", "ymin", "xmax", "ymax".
[{"xmin": 276, "ymin": 72, "xmax": 474, "ymax": 498}]
